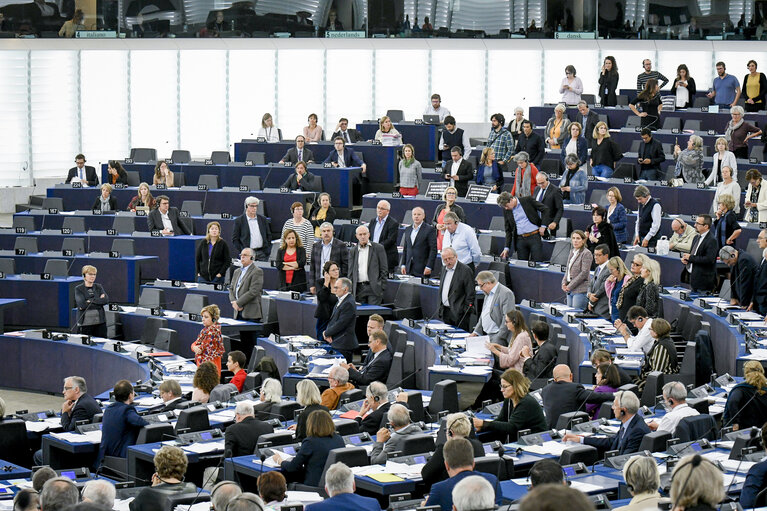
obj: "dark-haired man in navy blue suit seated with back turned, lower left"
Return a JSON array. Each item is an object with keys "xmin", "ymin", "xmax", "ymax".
[{"xmin": 97, "ymin": 380, "xmax": 149, "ymax": 466}]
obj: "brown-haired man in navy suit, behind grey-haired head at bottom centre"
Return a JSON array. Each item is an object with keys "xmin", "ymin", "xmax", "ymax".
[{"xmin": 425, "ymin": 438, "xmax": 503, "ymax": 511}]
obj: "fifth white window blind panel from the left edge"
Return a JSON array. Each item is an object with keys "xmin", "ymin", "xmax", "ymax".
[{"xmin": 180, "ymin": 50, "xmax": 228, "ymax": 159}]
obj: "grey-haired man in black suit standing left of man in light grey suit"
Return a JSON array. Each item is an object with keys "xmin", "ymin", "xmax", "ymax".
[{"xmin": 439, "ymin": 247, "xmax": 474, "ymax": 332}]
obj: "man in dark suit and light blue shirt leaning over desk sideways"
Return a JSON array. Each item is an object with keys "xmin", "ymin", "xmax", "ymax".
[{"xmin": 498, "ymin": 192, "xmax": 549, "ymax": 261}]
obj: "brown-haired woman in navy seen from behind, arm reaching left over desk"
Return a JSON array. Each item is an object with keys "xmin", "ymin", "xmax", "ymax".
[{"xmin": 272, "ymin": 410, "xmax": 344, "ymax": 486}]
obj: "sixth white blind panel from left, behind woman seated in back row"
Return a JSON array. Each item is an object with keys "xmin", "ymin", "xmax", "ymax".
[{"xmin": 229, "ymin": 50, "xmax": 278, "ymax": 143}]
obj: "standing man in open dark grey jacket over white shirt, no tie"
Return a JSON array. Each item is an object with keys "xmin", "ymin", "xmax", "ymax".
[{"xmin": 349, "ymin": 225, "xmax": 389, "ymax": 305}]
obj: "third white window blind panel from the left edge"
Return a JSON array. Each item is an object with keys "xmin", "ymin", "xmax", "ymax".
[{"xmin": 80, "ymin": 50, "xmax": 130, "ymax": 162}]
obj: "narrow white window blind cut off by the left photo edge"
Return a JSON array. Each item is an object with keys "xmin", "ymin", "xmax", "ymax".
[{"xmin": 0, "ymin": 51, "xmax": 30, "ymax": 186}]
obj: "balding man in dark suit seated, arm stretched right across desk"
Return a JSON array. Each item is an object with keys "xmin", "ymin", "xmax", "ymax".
[{"xmin": 544, "ymin": 364, "xmax": 616, "ymax": 431}]
